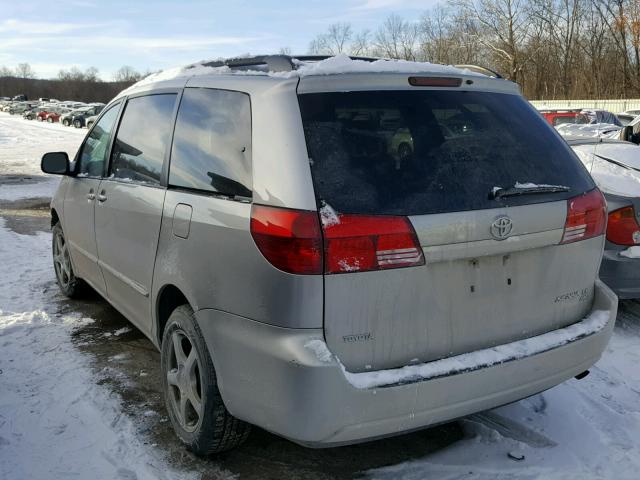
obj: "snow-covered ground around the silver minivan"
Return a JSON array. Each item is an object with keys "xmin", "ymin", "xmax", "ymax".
[{"xmin": 0, "ymin": 113, "xmax": 640, "ymax": 480}]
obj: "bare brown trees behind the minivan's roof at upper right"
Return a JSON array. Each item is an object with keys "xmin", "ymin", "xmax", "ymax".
[{"xmin": 309, "ymin": 0, "xmax": 640, "ymax": 99}]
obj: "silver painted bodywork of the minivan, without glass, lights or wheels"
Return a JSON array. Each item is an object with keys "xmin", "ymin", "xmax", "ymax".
[{"xmin": 52, "ymin": 66, "xmax": 617, "ymax": 446}]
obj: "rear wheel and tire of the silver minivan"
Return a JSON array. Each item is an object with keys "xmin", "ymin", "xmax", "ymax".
[{"xmin": 161, "ymin": 305, "xmax": 251, "ymax": 455}]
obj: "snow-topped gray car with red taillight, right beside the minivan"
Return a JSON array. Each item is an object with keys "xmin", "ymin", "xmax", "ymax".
[{"xmin": 568, "ymin": 138, "xmax": 640, "ymax": 299}]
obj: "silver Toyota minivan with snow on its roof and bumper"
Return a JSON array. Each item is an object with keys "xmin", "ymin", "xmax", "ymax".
[{"xmin": 42, "ymin": 55, "xmax": 617, "ymax": 454}]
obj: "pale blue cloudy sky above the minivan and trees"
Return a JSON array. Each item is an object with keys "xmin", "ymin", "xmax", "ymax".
[{"xmin": 0, "ymin": 0, "xmax": 437, "ymax": 80}]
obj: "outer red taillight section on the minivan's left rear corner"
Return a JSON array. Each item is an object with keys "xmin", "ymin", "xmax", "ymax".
[{"xmin": 251, "ymin": 205, "xmax": 322, "ymax": 275}]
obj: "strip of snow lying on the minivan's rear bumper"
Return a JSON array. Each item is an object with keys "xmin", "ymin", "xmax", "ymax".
[{"xmin": 305, "ymin": 310, "xmax": 609, "ymax": 389}]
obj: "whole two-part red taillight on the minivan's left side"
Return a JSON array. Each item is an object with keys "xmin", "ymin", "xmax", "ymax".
[{"xmin": 251, "ymin": 204, "xmax": 424, "ymax": 275}]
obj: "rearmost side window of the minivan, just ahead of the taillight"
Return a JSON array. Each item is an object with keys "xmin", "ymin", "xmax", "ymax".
[{"xmin": 169, "ymin": 88, "xmax": 251, "ymax": 197}]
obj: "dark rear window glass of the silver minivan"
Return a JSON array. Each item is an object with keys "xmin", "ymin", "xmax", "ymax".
[{"xmin": 299, "ymin": 90, "xmax": 594, "ymax": 215}]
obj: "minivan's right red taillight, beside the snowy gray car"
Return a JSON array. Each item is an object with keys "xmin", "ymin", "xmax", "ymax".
[{"xmin": 560, "ymin": 188, "xmax": 607, "ymax": 243}]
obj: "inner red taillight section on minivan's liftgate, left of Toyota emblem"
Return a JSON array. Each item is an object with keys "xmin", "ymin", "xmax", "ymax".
[{"xmin": 323, "ymin": 215, "xmax": 424, "ymax": 273}]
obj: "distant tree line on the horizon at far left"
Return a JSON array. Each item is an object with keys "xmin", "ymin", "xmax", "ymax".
[{"xmin": 0, "ymin": 63, "xmax": 143, "ymax": 103}]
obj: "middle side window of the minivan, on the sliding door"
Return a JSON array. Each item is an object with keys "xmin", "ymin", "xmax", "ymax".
[{"xmin": 111, "ymin": 94, "xmax": 176, "ymax": 183}]
